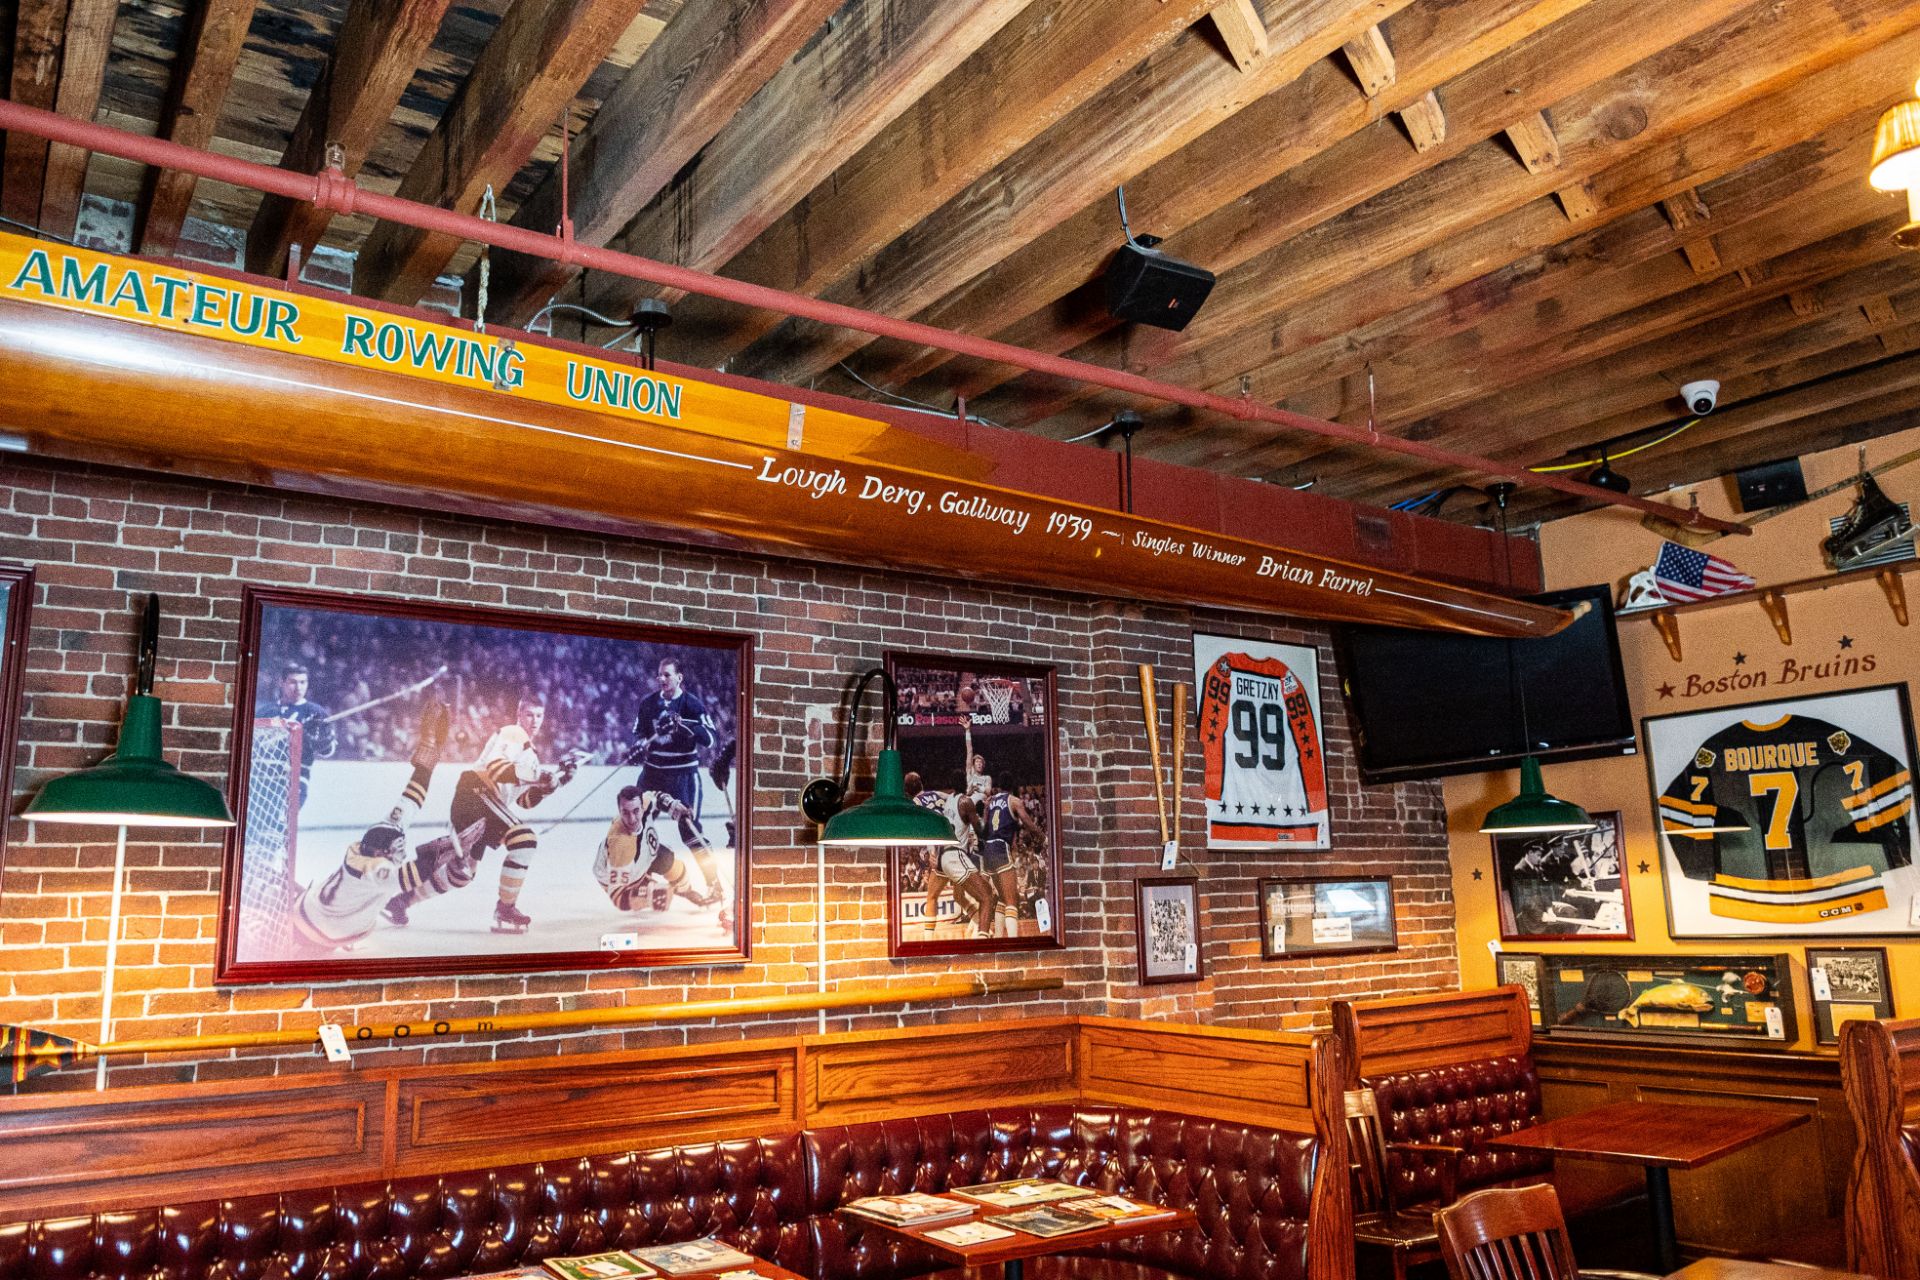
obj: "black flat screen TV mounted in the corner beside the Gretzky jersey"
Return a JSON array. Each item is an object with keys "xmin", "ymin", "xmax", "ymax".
[{"xmin": 1334, "ymin": 585, "xmax": 1636, "ymax": 783}]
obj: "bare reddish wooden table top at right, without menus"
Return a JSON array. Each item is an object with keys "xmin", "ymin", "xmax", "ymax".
[{"xmin": 1486, "ymin": 1102, "xmax": 1814, "ymax": 1174}]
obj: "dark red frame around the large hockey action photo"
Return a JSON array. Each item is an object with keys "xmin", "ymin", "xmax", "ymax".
[{"xmin": 215, "ymin": 585, "xmax": 755, "ymax": 983}]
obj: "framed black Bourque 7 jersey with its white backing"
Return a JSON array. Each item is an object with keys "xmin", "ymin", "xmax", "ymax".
[{"xmin": 1642, "ymin": 685, "xmax": 1920, "ymax": 938}]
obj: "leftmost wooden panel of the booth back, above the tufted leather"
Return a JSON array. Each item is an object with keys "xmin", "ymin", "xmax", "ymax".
[{"xmin": 0, "ymin": 1073, "xmax": 390, "ymax": 1222}]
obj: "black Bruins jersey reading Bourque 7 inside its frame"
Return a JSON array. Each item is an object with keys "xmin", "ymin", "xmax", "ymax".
[{"xmin": 1659, "ymin": 716, "xmax": 1912, "ymax": 923}]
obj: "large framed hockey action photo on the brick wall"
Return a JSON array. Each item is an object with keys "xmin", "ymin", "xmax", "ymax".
[{"xmin": 217, "ymin": 587, "xmax": 753, "ymax": 983}]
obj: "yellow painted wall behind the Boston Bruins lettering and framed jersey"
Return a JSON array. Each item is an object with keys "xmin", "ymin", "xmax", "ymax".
[{"xmin": 1446, "ymin": 430, "xmax": 1920, "ymax": 1054}]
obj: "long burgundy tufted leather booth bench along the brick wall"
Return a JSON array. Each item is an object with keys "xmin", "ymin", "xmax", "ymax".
[{"xmin": 0, "ymin": 1103, "xmax": 1320, "ymax": 1280}]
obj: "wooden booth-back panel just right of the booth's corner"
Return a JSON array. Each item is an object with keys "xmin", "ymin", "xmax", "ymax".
[{"xmin": 1081, "ymin": 1017, "xmax": 1315, "ymax": 1132}]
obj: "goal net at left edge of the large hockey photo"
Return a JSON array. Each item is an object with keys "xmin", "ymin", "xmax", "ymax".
[{"xmin": 240, "ymin": 716, "xmax": 300, "ymax": 960}]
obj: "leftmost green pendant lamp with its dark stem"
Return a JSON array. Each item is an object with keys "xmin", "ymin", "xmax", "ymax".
[{"xmin": 23, "ymin": 595, "xmax": 234, "ymax": 827}]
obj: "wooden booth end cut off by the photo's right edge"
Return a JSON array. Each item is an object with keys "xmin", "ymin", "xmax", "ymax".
[{"xmin": 1839, "ymin": 1019, "xmax": 1920, "ymax": 1280}]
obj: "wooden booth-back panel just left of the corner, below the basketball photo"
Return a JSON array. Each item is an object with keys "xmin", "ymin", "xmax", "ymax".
[{"xmin": 806, "ymin": 1017, "xmax": 1075, "ymax": 1126}]
